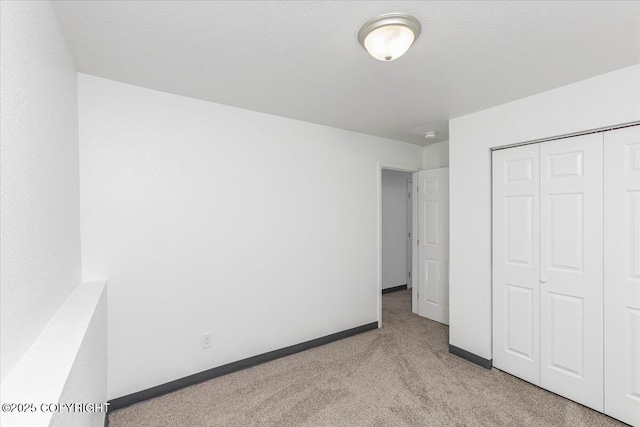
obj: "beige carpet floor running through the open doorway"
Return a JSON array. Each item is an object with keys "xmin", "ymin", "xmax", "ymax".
[{"xmin": 110, "ymin": 291, "xmax": 623, "ymax": 427}]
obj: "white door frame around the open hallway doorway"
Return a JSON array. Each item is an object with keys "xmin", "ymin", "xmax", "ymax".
[{"xmin": 376, "ymin": 160, "xmax": 420, "ymax": 328}]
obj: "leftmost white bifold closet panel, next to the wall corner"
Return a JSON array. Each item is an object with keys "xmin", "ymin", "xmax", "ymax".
[{"xmin": 493, "ymin": 144, "xmax": 540, "ymax": 385}]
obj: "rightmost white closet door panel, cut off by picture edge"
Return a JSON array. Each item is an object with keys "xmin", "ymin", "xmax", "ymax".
[{"xmin": 604, "ymin": 126, "xmax": 640, "ymax": 426}]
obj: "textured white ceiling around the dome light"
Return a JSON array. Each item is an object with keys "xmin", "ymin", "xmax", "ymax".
[{"xmin": 54, "ymin": 1, "xmax": 640, "ymax": 145}]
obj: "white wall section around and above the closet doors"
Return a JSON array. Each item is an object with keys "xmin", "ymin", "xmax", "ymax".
[{"xmin": 449, "ymin": 65, "xmax": 640, "ymax": 359}]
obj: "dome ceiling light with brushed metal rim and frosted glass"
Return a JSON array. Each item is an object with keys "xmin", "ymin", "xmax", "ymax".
[{"xmin": 358, "ymin": 13, "xmax": 422, "ymax": 61}]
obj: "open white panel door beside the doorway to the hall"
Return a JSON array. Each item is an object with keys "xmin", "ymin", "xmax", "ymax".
[{"xmin": 418, "ymin": 168, "xmax": 449, "ymax": 325}]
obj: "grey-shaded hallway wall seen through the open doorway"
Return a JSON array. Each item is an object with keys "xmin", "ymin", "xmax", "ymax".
[{"xmin": 382, "ymin": 169, "xmax": 411, "ymax": 289}]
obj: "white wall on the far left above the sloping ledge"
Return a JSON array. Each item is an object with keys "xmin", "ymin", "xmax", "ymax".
[{"xmin": 0, "ymin": 1, "xmax": 80, "ymax": 380}]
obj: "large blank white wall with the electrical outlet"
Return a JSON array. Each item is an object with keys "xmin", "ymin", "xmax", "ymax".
[{"xmin": 79, "ymin": 75, "xmax": 422, "ymax": 398}]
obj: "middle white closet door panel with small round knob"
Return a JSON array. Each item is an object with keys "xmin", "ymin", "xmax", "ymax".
[{"xmin": 540, "ymin": 133, "xmax": 603, "ymax": 411}]
